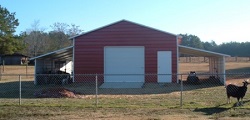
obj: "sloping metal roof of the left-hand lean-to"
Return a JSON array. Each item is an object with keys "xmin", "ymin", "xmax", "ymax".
[{"xmin": 30, "ymin": 46, "xmax": 73, "ymax": 61}]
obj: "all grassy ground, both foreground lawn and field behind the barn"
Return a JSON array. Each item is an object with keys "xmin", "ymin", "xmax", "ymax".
[{"xmin": 0, "ymin": 62, "xmax": 250, "ymax": 120}]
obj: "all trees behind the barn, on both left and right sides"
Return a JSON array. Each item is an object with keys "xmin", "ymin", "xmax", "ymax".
[{"xmin": 0, "ymin": 5, "xmax": 250, "ymax": 57}]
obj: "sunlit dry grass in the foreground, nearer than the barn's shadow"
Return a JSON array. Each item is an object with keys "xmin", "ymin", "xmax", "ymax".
[{"xmin": 0, "ymin": 85, "xmax": 250, "ymax": 120}]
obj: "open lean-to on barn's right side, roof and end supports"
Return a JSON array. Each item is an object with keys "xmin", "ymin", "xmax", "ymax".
[{"xmin": 178, "ymin": 45, "xmax": 230, "ymax": 84}]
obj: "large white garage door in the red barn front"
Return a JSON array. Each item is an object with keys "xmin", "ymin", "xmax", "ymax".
[{"xmin": 104, "ymin": 46, "xmax": 145, "ymax": 82}]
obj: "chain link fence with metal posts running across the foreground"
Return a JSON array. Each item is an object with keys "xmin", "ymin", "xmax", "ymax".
[{"xmin": 0, "ymin": 73, "xmax": 250, "ymax": 108}]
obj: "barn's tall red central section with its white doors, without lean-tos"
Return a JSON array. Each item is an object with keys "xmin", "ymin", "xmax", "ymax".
[{"xmin": 72, "ymin": 20, "xmax": 178, "ymax": 82}]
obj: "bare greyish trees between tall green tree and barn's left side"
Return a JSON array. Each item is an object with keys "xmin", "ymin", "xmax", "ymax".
[{"xmin": 21, "ymin": 21, "xmax": 82, "ymax": 57}]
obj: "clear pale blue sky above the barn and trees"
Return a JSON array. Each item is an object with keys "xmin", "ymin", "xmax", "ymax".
[{"xmin": 0, "ymin": 0, "xmax": 250, "ymax": 44}]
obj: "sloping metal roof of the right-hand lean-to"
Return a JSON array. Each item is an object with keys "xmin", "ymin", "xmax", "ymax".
[{"xmin": 178, "ymin": 45, "xmax": 230, "ymax": 57}]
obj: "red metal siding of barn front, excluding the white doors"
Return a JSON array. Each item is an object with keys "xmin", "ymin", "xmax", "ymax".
[{"xmin": 74, "ymin": 21, "xmax": 177, "ymax": 82}]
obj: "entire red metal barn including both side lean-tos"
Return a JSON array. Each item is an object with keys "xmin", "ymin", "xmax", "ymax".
[{"xmin": 31, "ymin": 20, "xmax": 229, "ymax": 86}]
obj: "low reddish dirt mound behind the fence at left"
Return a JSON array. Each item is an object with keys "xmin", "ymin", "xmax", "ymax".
[{"xmin": 34, "ymin": 87, "xmax": 84, "ymax": 98}]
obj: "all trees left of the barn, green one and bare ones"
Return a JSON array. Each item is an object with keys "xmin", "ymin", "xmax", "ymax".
[{"xmin": 0, "ymin": 5, "xmax": 83, "ymax": 57}]
